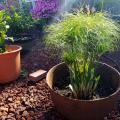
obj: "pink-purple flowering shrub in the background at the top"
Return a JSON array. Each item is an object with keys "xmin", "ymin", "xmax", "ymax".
[{"xmin": 32, "ymin": 0, "xmax": 60, "ymax": 19}]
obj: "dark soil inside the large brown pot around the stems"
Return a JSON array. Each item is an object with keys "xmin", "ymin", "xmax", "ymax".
[{"xmin": 53, "ymin": 67, "xmax": 116, "ymax": 100}]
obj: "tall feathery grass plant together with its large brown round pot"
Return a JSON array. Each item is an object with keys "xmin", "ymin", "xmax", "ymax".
[{"xmin": 46, "ymin": 8, "xmax": 120, "ymax": 120}]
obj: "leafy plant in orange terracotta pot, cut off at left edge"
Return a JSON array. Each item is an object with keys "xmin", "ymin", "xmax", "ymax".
[{"xmin": 0, "ymin": 10, "xmax": 21, "ymax": 83}]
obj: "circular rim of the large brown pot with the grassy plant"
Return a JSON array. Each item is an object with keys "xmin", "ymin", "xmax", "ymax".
[{"xmin": 46, "ymin": 62, "xmax": 120, "ymax": 102}]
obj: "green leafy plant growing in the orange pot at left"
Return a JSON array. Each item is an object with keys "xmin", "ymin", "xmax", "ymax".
[{"xmin": 0, "ymin": 10, "xmax": 12, "ymax": 53}]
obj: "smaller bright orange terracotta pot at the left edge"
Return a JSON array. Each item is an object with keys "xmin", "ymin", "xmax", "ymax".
[{"xmin": 0, "ymin": 45, "xmax": 22, "ymax": 84}]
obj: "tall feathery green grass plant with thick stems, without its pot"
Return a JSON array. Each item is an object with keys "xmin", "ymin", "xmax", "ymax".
[{"xmin": 46, "ymin": 12, "xmax": 119, "ymax": 99}]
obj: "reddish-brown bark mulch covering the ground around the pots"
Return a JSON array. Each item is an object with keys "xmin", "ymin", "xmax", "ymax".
[{"xmin": 0, "ymin": 41, "xmax": 120, "ymax": 120}]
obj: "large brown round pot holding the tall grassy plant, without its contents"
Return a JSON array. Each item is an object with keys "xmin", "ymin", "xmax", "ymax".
[{"xmin": 46, "ymin": 63, "xmax": 120, "ymax": 120}]
